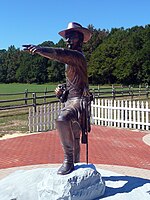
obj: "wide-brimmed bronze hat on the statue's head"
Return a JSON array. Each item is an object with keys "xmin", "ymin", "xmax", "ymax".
[{"xmin": 59, "ymin": 22, "xmax": 92, "ymax": 42}]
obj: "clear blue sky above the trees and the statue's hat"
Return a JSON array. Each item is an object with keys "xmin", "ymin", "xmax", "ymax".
[{"xmin": 0, "ymin": 0, "xmax": 150, "ymax": 49}]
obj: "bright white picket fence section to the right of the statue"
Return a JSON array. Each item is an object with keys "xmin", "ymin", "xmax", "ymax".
[{"xmin": 92, "ymin": 99, "xmax": 150, "ymax": 130}]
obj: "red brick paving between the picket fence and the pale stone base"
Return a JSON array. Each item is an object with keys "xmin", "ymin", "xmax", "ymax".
[{"xmin": 0, "ymin": 126, "xmax": 150, "ymax": 170}]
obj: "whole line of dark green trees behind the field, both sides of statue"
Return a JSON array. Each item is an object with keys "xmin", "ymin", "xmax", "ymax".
[{"xmin": 0, "ymin": 24, "xmax": 150, "ymax": 85}]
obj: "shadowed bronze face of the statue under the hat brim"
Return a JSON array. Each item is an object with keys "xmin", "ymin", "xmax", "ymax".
[{"xmin": 65, "ymin": 31, "xmax": 80, "ymax": 49}]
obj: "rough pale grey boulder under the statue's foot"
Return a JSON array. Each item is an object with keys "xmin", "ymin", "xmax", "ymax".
[{"xmin": 38, "ymin": 165, "xmax": 105, "ymax": 200}]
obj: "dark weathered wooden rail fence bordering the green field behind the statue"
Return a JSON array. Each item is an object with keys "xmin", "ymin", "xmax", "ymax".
[{"xmin": 0, "ymin": 86, "xmax": 150, "ymax": 110}]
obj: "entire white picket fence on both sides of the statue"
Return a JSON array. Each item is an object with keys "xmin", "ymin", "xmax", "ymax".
[{"xmin": 29, "ymin": 99, "xmax": 150, "ymax": 132}]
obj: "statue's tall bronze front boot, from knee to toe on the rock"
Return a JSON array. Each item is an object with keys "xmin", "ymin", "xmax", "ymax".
[{"xmin": 56, "ymin": 121, "xmax": 74, "ymax": 175}]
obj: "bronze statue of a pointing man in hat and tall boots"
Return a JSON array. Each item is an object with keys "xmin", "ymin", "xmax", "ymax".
[{"xmin": 24, "ymin": 22, "xmax": 92, "ymax": 175}]
